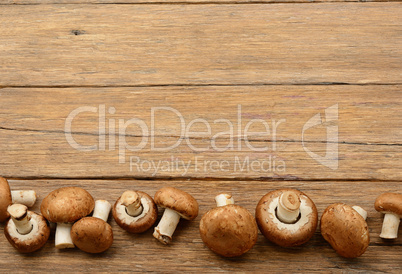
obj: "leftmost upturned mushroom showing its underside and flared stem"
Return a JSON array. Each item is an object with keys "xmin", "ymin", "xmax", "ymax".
[{"xmin": 4, "ymin": 204, "xmax": 50, "ymax": 253}]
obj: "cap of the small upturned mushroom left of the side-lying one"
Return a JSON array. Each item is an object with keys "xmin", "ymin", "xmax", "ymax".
[{"xmin": 113, "ymin": 191, "xmax": 158, "ymax": 233}]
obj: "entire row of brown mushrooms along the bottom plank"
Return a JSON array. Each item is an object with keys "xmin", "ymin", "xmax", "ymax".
[{"xmin": 0, "ymin": 177, "xmax": 402, "ymax": 258}]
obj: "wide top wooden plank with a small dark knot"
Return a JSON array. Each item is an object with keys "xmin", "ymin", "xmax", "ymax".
[{"xmin": 0, "ymin": 3, "xmax": 402, "ymax": 86}]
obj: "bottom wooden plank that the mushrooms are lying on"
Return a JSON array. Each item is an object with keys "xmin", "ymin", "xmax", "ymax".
[{"xmin": 0, "ymin": 180, "xmax": 402, "ymax": 273}]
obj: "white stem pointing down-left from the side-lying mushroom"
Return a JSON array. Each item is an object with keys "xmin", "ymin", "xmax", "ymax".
[{"xmin": 153, "ymin": 208, "xmax": 180, "ymax": 244}]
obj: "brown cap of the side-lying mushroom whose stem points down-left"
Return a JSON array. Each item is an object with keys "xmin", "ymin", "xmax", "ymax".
[{"xmin": 154, "ymin": 187, "xmax": 198, "ymax": 220}]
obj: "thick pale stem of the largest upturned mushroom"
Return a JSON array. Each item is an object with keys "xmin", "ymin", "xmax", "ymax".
[{"xmin": 276, "ymin": 191, "xmax": 300, "ymax": 224}]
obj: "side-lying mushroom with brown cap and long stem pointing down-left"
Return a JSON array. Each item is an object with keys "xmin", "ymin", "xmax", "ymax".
[{"xmin": 153, "ymin": 187, "xmax": 198, "ymax": 244}]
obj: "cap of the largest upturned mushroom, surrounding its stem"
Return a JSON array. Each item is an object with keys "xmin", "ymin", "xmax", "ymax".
[{"xmin": 255, "ymin": 189, "xmax": 318, "ymax": 247}]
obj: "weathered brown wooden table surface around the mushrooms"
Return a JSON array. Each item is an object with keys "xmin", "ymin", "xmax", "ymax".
[{"xmin": 0, "ymin": 0, "xmax": 402, "ymax": 273}]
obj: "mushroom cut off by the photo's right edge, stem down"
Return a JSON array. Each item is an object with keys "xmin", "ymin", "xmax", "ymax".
[{"xmin": 374, "ymin": 193, "xmax": 402, "ymax": 239}]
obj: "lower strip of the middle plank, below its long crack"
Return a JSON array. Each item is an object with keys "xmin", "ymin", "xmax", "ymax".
[{"xmin": 0, "ymin": 130, "xmax": 402, "ymax": 180}]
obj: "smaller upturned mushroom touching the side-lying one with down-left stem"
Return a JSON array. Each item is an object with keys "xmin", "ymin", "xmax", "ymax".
[{"xmin": 113, "ymin": 190, "xmax": 158, "ymax": 233}]
